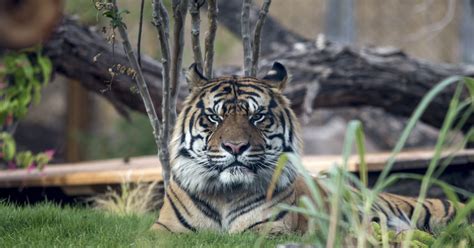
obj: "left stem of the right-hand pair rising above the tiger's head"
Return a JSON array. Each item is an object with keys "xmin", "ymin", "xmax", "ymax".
[{"xmin": 240, "ymin": 0, "xmax": 252, "ymax": 76}]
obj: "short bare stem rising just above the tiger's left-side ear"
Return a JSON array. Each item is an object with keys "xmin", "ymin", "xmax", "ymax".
[{"xmin": 189, "ymin": 0, "xmax": 205, "ymax": 71}]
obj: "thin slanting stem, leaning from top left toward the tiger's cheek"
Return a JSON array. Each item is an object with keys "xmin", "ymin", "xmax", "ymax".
[{"xmin": 112, "ymin": 0, "xmax": 165, "ymax": 176}]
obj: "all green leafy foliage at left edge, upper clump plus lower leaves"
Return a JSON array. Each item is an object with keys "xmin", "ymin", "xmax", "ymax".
[{"xmin": 0, "ymin": 49, "xmax": 54, "ymax": 169}]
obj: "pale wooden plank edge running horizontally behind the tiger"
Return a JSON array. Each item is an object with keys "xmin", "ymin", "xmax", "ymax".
[{"xmin": 0, "ymin": 149, "xmax": 474, "ymax": 188}]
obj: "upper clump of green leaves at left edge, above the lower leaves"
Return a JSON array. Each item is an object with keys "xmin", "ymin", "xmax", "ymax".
[{"xmin": 0, "ymin": 51, "xmax": 52, "ymax": 124}]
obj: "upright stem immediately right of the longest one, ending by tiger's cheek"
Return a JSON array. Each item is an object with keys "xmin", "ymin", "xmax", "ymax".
[{"xmin": 167, "ymin": 0, "xmax": 188, "ymax": 127}]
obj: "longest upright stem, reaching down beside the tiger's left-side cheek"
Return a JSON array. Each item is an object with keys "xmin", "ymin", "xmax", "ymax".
[{"xmin": 153, "ymin": 0, "xmax": 171, "ymax": 188}]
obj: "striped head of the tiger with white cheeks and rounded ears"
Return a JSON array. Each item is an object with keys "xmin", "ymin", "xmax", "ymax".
[{"xmin": 170, "ymin": 63, "xmax": 301, "ymax": 194}]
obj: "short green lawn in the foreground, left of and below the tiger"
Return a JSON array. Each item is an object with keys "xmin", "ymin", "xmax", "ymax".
[{"xmin": 0, "ymin": 203, "xmax": 302, "ymax": 247}]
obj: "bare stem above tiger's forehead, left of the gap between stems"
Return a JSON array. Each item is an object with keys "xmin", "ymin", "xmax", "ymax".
[{"xmin": 205, "ymin": 0, "xmax": 218, "ymax": 79}]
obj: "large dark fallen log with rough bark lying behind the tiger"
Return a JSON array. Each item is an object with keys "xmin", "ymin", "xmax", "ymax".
[{"xmin": 44, "ymin": 19, "xmax": 474, "ymax": 132}]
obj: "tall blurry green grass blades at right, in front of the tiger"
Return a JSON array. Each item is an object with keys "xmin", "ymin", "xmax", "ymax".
[{"xmin": 270, "ymin": 77, "xmax": 474, "ymax": 247}]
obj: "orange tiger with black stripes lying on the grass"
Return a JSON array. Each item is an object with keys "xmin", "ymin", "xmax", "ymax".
[{"xmin": 152, "ymin": 62, "xmax": 462, "ymax": 233}]
